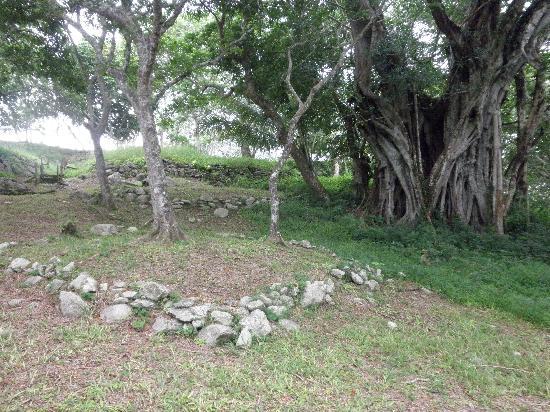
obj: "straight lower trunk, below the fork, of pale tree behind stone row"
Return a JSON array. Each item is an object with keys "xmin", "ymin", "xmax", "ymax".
[{"xmin": 137, "ymin": 98, "xmax": 185, "ymax": 240}]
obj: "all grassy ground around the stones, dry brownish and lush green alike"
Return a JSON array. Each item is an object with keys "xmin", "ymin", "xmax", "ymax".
[{"xmin": 0, "ymin": 154, "xmax": 550, "ymax": 411}]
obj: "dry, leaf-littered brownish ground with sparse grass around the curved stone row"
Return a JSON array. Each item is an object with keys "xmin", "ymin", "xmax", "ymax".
[{"xmin": 0, "ymin": 175, "xmax": 550, "ymax": 411}]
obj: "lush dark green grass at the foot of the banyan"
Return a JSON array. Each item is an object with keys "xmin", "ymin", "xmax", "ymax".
[{"xmin": 242, "ymin": 178, "xmax": 550, "ymax": 327}]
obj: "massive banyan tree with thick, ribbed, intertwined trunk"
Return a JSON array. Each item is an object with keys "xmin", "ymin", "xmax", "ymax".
[{"xmin": 348, "ymin": 0, "xmax": 550, "ymax": 232}]
